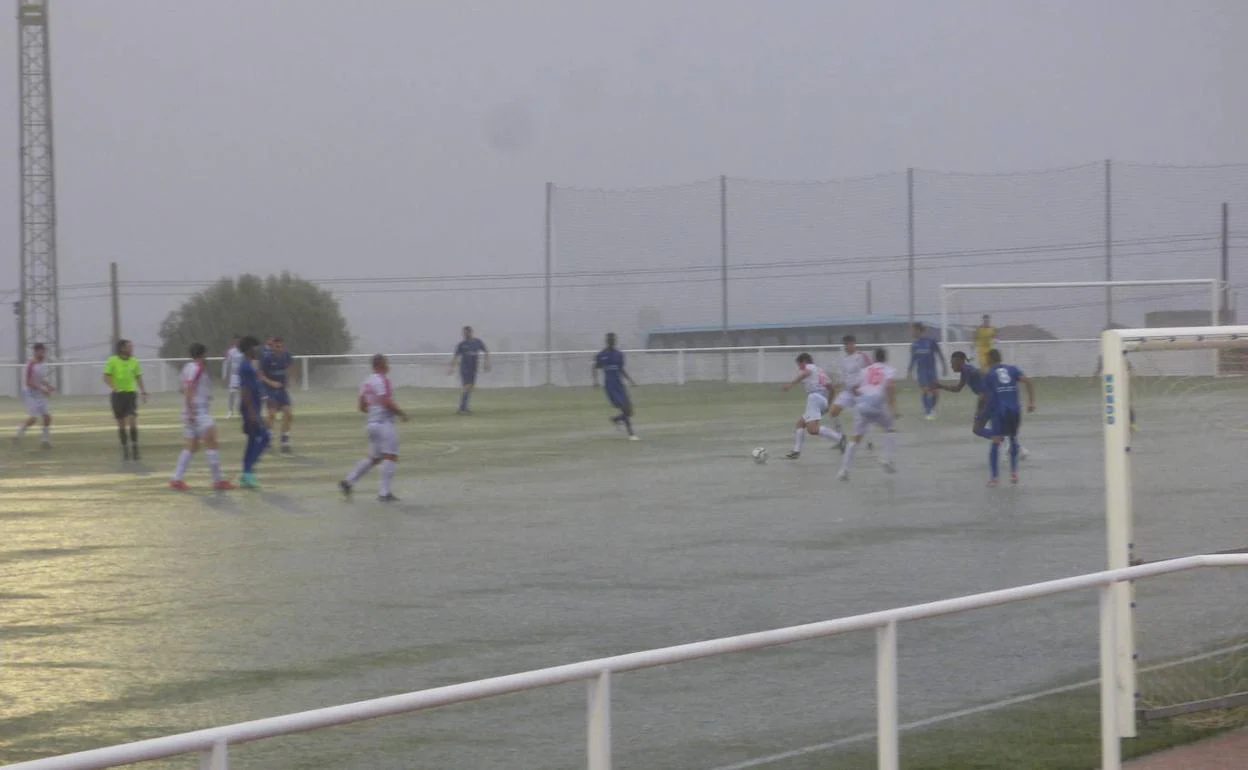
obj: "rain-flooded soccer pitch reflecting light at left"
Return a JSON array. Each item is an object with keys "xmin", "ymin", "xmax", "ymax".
[{"xmin": 0, "ymin": 379, "xmax": 1248, "ymax": 770}]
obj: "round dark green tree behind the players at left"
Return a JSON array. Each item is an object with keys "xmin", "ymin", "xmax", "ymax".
[{"xmin": 160, "ymin": 272, "xmax": 352, "ymax": 358}]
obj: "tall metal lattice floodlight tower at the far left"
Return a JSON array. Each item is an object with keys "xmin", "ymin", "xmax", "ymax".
[{"xmin": 16, "ymin": 0, "xmax": 61, "ymax": 369}]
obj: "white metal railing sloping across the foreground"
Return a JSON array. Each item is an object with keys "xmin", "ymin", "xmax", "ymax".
[{"xmin": 6, "ymin": 554, "xmax": 1248, "ymax": 770}]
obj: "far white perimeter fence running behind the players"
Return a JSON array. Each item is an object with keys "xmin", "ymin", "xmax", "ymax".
[{"xmin": 0, "ymin": 339, "xmax": 1239, "ymax": 396}]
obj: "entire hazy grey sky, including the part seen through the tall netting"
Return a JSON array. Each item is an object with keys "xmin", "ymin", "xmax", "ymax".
[{"xmin": 0, "ymin": 0, "xmax": 1248, "ymax": 358}]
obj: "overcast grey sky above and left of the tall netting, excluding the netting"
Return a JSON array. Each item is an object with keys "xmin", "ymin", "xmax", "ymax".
[{"xmin": 0, "ymin": 0, "xmax": 1248, "ymax": 354}]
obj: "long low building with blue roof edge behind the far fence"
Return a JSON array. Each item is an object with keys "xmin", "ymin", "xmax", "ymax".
[{"xmin": 645, "ymin": 316, "xmax": 971, "ymax": 349}]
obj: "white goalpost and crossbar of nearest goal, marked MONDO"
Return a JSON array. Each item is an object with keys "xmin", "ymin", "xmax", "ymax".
[{"xmin": 1101, "ymin": 321, "xmax": 1248, "ymax": 738}]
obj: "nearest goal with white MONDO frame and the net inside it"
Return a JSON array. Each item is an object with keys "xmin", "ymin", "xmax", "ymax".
[{"xmin": 1098, "ymin": 326, "xmax": 1248, "ymax": 736}]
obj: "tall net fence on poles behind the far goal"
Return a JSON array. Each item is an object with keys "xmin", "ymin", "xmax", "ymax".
[{"xmin": 548, "ymin": 163, "xmax": 1248, "ymax": 379}]
